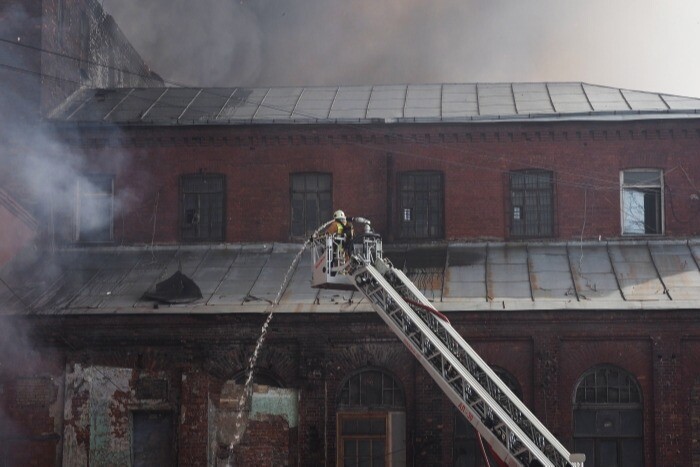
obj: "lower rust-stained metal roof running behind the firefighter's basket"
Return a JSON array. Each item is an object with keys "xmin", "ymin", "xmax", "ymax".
[{"xmin": 0, "ymin": 239, "xmax": 700, "ymax": 314}]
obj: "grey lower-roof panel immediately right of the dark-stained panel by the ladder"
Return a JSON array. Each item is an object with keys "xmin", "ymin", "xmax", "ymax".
[{"xmin": 443, "ymin": 245, "xmax": 486, "ymax": 301}]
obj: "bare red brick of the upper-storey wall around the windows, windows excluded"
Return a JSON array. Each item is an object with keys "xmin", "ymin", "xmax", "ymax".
[{"xmin": 56, "ymin": 121, "xmax": 700, "ymax": 244}]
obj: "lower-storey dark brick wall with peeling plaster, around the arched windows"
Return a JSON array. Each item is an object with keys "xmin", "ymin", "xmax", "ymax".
[{"xmin": 3, "ymin": 311, "xmax": 700, "ymax": 466}]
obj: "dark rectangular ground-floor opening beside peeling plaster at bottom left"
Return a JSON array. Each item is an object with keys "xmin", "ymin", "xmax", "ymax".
[{"xmin": 131, "ymin": 410, "xmax": 176, "ymax": 467}]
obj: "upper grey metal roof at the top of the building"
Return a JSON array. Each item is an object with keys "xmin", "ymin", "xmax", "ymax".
[{"xmin": 51, "ymin": 82, "xmax": 700, "ymax": 125}]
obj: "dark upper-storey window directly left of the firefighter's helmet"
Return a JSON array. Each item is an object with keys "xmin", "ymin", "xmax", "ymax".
[{"xmin": 290, "ymin": 173, "xmax": 333, "ymax": 238}]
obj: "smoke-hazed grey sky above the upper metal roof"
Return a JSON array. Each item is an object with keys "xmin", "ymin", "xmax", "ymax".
[{"xmin": 101, "ymin": 0, "xmax": 700, "ymax": 97}]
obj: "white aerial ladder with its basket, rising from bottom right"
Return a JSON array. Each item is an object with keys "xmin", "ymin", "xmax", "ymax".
[{"xmin": 311, "ymin": 217, "xmax": 585, "ymax": 467}]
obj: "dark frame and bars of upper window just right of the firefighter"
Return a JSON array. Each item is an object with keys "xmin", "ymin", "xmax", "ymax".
[{"xmin": 396, "ymin": 170, "xmax": 445, "ymax": 240}]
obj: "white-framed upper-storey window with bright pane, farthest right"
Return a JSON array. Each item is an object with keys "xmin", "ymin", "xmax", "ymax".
[{"xmin": 620, "ymin": 169, "xmax": 664, "ymax": 235}]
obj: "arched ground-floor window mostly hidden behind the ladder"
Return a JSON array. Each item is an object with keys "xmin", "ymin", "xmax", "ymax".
[{"xmin": 452, "ymin": 367, "xmax": 523, "ymax": 467}]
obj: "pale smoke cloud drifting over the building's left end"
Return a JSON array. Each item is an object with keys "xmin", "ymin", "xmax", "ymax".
[{"xmin": 0, "ymin": 3, "xmax": 142, "ymax": 252}]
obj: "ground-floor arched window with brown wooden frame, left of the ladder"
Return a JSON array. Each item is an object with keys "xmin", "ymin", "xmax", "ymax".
[{"xmin": 337, "ymin": 368, "xmax": 406, "ymax": 467}]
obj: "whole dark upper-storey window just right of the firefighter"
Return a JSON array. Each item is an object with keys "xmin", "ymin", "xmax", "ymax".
[{"xmin": 399, "ymin": 172, "xmax": 444, "ymax": 238}]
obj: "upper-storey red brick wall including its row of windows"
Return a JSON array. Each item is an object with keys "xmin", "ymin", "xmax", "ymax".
[{"xmin": 45, "ymin": 120, "xmax": 700, "ymax": 244}]
